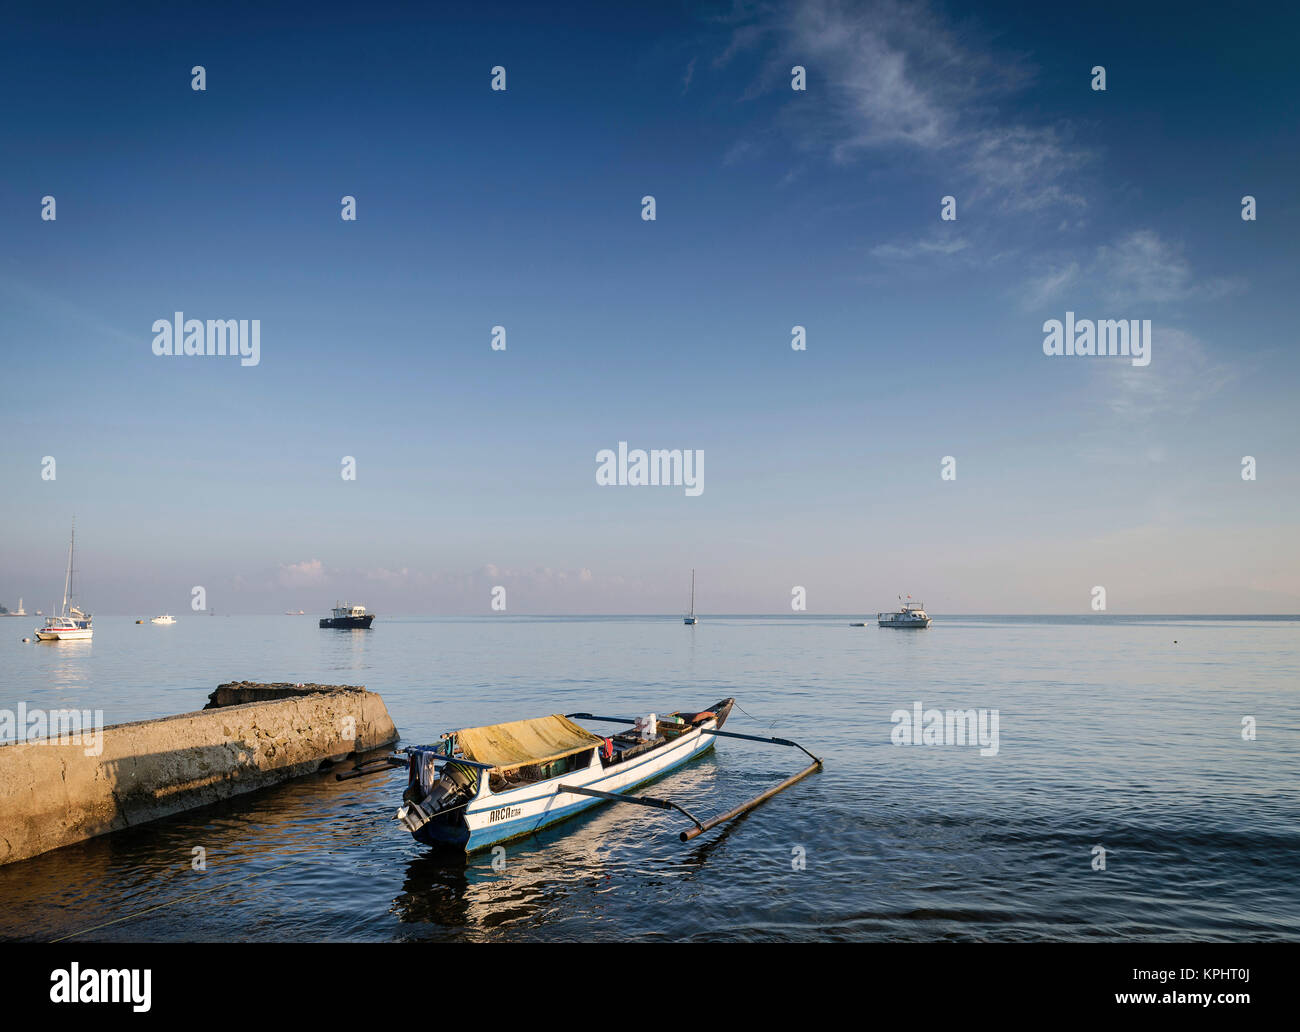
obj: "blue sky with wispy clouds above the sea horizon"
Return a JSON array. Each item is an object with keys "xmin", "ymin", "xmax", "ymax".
[{"xmin": 0, "ymin": 0, "xmax": 1300, "ymax": 613}]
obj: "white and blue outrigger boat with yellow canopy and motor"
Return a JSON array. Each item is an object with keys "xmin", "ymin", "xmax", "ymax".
[{"xmin": 387, "ymin": 699, "xmax": 822, "ymax": 853}]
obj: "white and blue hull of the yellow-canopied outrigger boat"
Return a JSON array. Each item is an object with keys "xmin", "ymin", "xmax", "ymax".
[{"xmin": 412, "ymin": 699, "xmax": 731, "ymax": 853}]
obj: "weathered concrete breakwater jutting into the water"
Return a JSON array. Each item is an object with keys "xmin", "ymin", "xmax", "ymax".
[{"xmin": 0, "ymin": 681, "xmax": 398, "ymax": 864}]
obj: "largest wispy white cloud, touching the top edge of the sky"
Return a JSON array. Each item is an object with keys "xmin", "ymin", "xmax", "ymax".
[{"xmin": 719, "ymin": 0, "xmax": 1091, "ymax": 212}]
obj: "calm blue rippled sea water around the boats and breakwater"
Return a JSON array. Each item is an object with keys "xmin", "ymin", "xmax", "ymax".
[{"xmin": 0, "ymin": 615, "xmax": 1300, "ymax": 941}]
